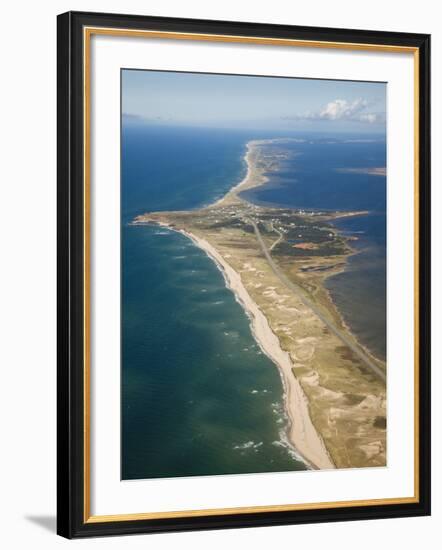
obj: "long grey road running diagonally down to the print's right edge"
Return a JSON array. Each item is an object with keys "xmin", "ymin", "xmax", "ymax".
[{"xmin": 246, "ymin": 219, "xmax": 386, "ymax": 382}]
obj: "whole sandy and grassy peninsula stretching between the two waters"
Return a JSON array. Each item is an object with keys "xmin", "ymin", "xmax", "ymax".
[{"xmin": 132, "ymin": 139, "xmax": 386, "ymax": 469}]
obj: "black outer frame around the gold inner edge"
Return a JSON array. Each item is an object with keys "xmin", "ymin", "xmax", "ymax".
[{"xmin": 57, "ymin": 12, "xmax": 430, "ymax": 538}]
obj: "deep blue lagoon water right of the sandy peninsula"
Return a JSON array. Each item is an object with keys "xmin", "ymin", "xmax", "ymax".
[{"xmin": 244, "ymin": 136, "xmax": 386, "ymax": 359}]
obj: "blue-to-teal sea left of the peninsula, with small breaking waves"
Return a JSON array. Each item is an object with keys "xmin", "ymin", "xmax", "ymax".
[{"xmin": 122, "ymin": 129, "xmax": 305, "ymax": 479}]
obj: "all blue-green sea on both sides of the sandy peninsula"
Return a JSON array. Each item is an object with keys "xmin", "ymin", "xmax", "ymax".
[{"xmin": 121, "ymin": 124, "xmax": 385, "ymax": 479}]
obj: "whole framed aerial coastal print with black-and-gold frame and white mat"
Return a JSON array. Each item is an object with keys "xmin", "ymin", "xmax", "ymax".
[{"xmin": 58, "ymin": 12, "xmax": 430, "ymax": 538}]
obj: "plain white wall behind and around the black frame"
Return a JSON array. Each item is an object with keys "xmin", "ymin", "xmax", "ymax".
[{"xmin": 0, "ymin": 0, "xmax": 442, "ymax": 550}]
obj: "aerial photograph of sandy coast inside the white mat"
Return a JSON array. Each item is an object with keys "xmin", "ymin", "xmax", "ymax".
[{"xmin": 121, "ymin": 68, "xmax": 388, "ymax": 480}]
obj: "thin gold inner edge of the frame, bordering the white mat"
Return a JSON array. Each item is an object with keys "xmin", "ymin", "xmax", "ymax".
[{"xmin": 83, "ymin": 27, "xmax": 420, "ymax": 523}]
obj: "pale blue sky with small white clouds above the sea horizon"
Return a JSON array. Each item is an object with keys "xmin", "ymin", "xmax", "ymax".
[{"xmin": 122, "ymin": 69, "xmax": 386, "ymax": 133}]
